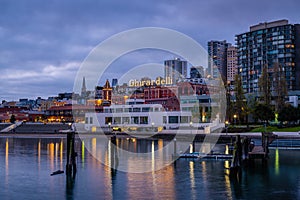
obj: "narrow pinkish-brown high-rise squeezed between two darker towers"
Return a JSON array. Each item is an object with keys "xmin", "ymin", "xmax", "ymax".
[{"xmin": 227, "ymin": 46, "xmax": 238, "ymax": 83}]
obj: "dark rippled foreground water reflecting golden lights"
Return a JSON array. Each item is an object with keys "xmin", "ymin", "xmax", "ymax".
[{"xmin": 0, "ymin": 137, "xmax": 300, "ymax": 200}]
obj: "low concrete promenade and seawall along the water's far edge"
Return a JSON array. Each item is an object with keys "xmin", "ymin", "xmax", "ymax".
[{"xmin": 0, "ymin": 123, "xmax": 300, "ymax": 142}]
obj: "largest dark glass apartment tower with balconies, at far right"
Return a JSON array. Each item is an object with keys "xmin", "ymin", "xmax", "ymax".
[{"xmin": 236, "ymin": 20, "xmax": 300, "ymax": 93}]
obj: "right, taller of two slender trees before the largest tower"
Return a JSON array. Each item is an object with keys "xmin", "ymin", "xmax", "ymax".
[{"xmin": 273, "ymin": 62, "xmax": 287, "ymax": 113}]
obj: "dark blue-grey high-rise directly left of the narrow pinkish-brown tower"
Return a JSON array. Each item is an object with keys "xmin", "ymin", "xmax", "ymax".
[{"xmin": 207, "ymin": 40, "xmax": 231, "ymax": 80}]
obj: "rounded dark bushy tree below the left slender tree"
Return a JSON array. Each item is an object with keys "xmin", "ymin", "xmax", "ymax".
[{"xmin": 253, "ymin": 103, "xmax": 274, "ymax": 123}]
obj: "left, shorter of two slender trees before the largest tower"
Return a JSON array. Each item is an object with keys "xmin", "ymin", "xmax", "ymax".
[{"xmin": 258, "ymin": 66, "xmax": 271, "ymax": 105}]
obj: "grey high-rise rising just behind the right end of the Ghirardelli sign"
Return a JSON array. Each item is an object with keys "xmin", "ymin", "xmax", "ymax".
[{"xmin": 165, "ymin": 58, "xmax": 187, "ymax": 84}]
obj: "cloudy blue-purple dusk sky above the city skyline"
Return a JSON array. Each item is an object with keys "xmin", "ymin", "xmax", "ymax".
[{"xmin": 0, "ymin": 0, "xmax": 300, "ymax": 100}]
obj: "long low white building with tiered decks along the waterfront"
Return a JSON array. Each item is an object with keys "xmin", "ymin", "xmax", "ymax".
[{"xmin": 85, "ymin": 104, "xmax": 192, "ymax": 131}]
